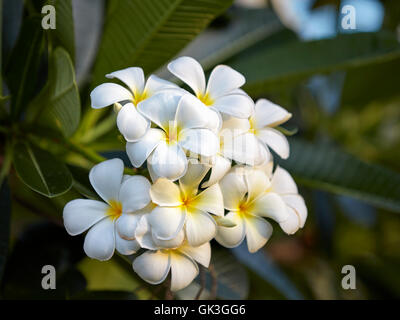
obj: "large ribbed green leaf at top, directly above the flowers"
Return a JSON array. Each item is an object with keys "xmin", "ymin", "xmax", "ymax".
[{"xmin": 94, "ymin": 0, "xmax": 232, "ymax": 84}]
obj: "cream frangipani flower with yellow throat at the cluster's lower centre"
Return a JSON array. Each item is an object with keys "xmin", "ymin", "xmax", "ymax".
[{"xmin": 148, "ymin": 164, "xmax": 224, "ymax": 246}]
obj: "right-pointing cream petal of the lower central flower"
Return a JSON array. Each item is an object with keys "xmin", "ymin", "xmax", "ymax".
[{"xmin": 190, "ymin": 183, "xmax": 224, "ymax": 216}]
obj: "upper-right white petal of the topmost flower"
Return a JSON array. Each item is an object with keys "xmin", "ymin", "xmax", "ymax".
[{"xmin": 207, "ymin": 65, "xmax": 246, "ymax": 99}]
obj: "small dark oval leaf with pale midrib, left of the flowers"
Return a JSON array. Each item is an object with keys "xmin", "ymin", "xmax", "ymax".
[{"xmin": 13, "ymin": 142, "xmax": 72, "ymax": 198}]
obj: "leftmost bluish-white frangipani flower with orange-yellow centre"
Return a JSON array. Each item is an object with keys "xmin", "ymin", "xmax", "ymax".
[{"xmin": 63, "ymin": 159, "xmax": 150, "ymax": 260}]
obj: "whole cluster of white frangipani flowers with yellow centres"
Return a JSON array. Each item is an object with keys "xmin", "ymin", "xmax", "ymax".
[{"xmin": 63, "ymin": 57, "xmax": 307, "ymax": 291}]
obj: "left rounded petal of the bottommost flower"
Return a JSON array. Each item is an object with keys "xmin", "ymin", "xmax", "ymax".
[{"xmin": 132, "ymin": 251, "xmax": 171, "ymax": 284}]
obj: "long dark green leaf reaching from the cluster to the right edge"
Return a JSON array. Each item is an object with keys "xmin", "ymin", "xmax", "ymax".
[{"xmin": 278, "ymin": 139, "xmax": 400, "ymax": 212}]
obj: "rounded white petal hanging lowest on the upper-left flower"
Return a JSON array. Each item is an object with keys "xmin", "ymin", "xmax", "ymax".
[{"xmin": 117, "ymin": 103, "xmax": 150, "ymax": 142}]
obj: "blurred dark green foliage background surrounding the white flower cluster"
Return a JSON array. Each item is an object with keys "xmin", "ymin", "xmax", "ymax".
[{"xmin": 0, "ymin": 0, "xmax": 400, "ymax": 299}]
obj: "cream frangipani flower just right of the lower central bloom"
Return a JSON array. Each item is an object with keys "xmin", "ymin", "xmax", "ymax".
[{"xmin": 215, "ymin": 166, "xmax": 289, "ymax": 252}]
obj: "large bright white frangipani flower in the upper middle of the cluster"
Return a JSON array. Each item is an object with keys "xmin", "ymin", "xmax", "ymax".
[{"xmin": 126, "ymin": 91, "xmax": 219, "ymax": 180}]
